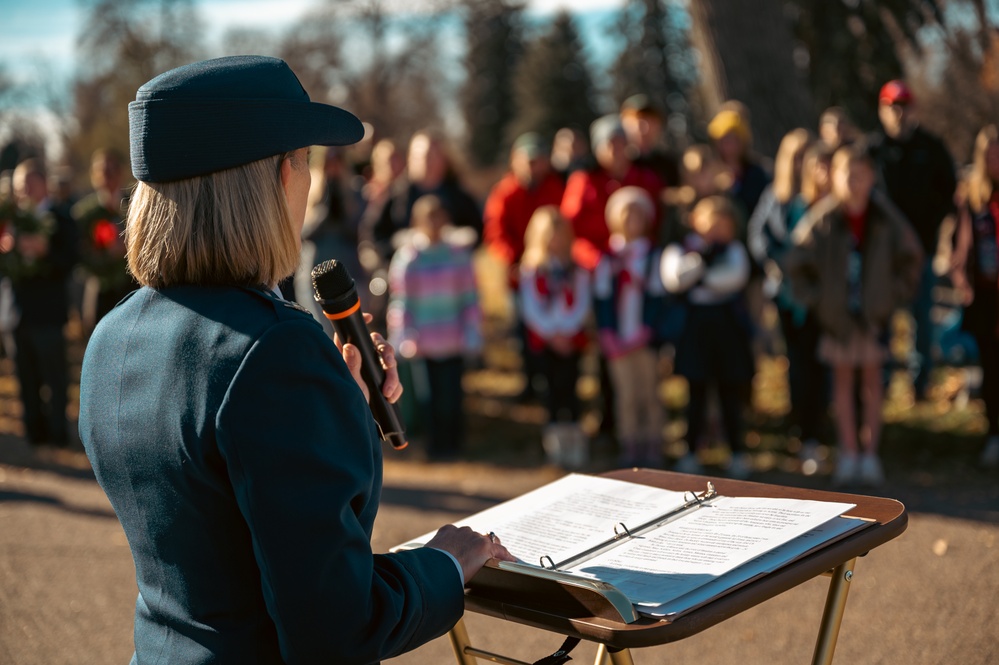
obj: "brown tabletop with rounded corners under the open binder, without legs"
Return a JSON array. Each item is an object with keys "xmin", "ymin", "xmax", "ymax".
[{"xmin": 465, "ymin": 469, "xmax": 908, "ymax": 648}]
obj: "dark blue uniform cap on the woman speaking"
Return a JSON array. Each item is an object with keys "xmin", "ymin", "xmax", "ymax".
[{"xmin": 128, "ymin": 55, "xmax": 364, "ymax": 182}]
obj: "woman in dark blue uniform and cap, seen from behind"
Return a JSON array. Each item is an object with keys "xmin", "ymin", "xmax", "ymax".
[{"xmin": 80, "ymin": 56, "xmax": 509, "ymax": 664}]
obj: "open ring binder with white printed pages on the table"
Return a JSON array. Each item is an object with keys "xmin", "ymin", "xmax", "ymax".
[{"xmin": 396, "ymin": 474, "xmax": 870, "ymax": 622}]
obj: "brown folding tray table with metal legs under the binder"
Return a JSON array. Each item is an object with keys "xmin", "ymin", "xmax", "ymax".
[{"xmin": 449, "ymin": 469, "xmax": 908, "ymax": 665}]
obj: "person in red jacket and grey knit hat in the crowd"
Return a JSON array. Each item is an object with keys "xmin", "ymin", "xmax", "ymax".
[{"xmin": 562, "ymin": 114, "xmax": 666, "ymax": 271}]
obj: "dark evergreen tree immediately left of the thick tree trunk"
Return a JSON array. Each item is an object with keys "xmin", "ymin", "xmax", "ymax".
[{"xmin": 609, "ymin": 0, "xmax": 696, "ymax": 138}]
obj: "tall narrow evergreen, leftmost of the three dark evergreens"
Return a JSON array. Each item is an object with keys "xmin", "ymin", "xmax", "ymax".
[{"xmin": 461, "ymin": 0, "xmax": 524, "ymax": 166}]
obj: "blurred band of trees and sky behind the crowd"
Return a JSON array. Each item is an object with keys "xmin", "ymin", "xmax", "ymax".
[{"xmin": 0, "ymin": 0, "xmax": 999, "ymax": 187}]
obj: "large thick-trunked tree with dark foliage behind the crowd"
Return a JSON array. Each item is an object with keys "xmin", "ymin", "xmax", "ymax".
[{"xmin": 690, "ymin": 0, "xmax": 948, "ymax": 154}]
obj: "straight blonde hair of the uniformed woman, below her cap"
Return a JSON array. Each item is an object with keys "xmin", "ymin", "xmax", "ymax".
[{"xmin": 125, "ymin": 153, "xmax": 305, "ymax": 288}]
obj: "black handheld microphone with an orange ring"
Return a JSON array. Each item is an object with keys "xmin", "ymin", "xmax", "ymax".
[{"xmin": 312, "ymin": 259, "xmax": 409, "ymax": 450}]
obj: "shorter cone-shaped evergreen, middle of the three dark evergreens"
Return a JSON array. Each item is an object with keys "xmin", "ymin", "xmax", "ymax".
[{"xmin": 507, "ymin": 10, "xmax": 597, "ymax": 147}]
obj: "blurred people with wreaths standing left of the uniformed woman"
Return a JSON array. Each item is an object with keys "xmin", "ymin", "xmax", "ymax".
[{"xmin": 0, "ymin": 150, "xmax": 135, "ymax": 447}]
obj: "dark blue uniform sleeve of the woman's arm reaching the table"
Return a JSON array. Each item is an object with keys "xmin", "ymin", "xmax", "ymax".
[{"xmin": 216, "ymin": 320, "xmax": 463, "ymax": 664}]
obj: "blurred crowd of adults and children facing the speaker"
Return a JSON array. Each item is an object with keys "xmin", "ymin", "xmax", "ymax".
[{"xmin": 0, "ymin": 81, "xmax": 999, "ymax": 486}]
